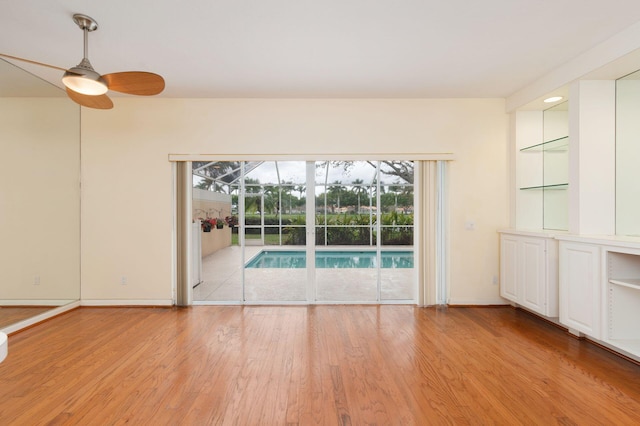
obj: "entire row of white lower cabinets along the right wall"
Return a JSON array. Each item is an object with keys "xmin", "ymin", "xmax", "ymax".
[{"xmin": 499, "ymin": 230, "xmax": 640, "ymax": 361}]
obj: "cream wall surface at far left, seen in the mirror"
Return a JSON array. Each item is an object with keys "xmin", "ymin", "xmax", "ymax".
[{"xmin": 0, "ymin": 97, "xmax": 80, "ymax": 305}]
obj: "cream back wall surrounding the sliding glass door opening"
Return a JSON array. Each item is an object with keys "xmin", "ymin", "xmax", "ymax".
[{"xmin": 82, "ymin": 98, "xmax": 509, "ymax": 304}]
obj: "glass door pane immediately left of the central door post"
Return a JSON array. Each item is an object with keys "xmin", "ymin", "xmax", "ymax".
[{"xmin": 239, "ymin": 161, "xmax": 308, "ymax": 303}]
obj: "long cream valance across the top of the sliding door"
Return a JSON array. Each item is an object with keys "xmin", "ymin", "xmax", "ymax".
[{"xmin": 169, "ymin": 152, "xmax": 455, "ymax": 161}]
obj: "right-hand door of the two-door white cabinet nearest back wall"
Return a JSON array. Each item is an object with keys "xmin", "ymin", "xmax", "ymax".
[{"xmin": 518, "ymin": 238, "xmax": 547, "ymax": 315}]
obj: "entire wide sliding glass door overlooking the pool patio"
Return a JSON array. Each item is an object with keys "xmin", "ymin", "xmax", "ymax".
[{"xmin": 194, "ymin": 161, "xmax": 416, "ymax": 303}]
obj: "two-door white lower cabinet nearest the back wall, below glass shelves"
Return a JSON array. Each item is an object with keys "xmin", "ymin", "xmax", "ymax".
[{"xmin": 500, "ymin": 231, "xmax": 558, "ymax": 317}]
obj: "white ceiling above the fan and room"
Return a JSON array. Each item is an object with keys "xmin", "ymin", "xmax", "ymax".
[{"xmin": 0, "ymin": 0, "xmax": 640, "ymax": 98}]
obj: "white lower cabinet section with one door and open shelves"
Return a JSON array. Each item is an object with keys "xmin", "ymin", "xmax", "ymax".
[{"xmin": 558, "ymin": 235, "xmax": 640, "ymax": 361}]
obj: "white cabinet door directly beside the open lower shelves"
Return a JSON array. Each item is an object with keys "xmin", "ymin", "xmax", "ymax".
[{"xmin": 560, "ymin": 241, "xmax": 601, "ymax": 339}]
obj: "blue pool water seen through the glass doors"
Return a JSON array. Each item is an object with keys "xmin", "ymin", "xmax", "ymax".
[{"xmin": 246, "ymin": 250, "xmax": 413, "ymax": 268}]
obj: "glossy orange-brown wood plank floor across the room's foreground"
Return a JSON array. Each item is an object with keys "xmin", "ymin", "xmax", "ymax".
[{"xmin": 0, "ymin": 305, "xmax": 640, "ymax": 425}]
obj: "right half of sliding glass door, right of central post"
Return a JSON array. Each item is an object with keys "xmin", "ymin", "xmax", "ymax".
[{"xmin": 315, "ymin": 161, "xmax": 416, "ymax": 303}]
